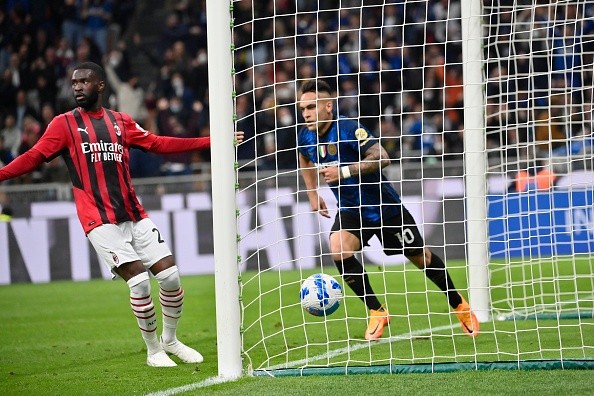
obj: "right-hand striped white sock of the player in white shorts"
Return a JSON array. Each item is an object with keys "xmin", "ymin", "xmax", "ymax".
[{"xmin": 155, "ymin": 266, "xmax": 184, "ymax": 344}]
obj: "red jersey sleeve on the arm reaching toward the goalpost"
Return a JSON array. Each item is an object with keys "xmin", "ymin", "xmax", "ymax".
[{"xmin": 123, "ymin": 114, "xmax": 210, "ymax": 154}]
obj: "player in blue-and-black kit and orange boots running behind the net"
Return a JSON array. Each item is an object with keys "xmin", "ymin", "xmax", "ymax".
[{"xmin": 298, "ymin": 80, "xmax": 479, "ymax": 340}]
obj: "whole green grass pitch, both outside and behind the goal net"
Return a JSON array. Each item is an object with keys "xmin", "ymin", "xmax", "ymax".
[{"xmin": 0, "ymin": 265, "xmax": 594, "ymax": 395}]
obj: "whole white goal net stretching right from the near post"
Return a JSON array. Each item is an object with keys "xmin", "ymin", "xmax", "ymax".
[{"xmin": 220, "ymin": 0, "xmax": 594, "ymax": 375}]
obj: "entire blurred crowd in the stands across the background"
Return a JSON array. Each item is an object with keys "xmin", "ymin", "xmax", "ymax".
[{"xmin": 0, "ymin": 0, "xmax": 594, "ymax": 183}]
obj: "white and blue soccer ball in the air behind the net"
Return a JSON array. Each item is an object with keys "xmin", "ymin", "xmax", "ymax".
[{"xmin": 300, "ymin": 274, "xmax": 342, "ymax": 316}]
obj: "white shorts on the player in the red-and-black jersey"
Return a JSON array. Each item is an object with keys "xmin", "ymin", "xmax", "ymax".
[{"xmin": 87, "ymin": 218, "xmax": 171, "ymax": 274}]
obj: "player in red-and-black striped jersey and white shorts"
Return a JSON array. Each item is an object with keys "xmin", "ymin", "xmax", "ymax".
[{"xmin": 0, "ymin": 62, "xmax": 243, "ymax": 367}]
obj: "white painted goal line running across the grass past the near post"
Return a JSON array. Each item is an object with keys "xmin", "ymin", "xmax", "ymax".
[{"xmin": 146, "ymin": 323, "xmax": 458, "ymax": 396}]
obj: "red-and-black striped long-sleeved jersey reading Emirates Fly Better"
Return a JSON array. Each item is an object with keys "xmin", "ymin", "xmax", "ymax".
[{"xmin": 0, "ymin": 108, "xmax": 210, "ymax": 233}]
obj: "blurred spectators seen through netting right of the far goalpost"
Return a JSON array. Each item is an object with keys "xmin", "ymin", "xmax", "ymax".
[{"xmin": 484, "ymin": 0, "xmax": 594, "ymax": 161}]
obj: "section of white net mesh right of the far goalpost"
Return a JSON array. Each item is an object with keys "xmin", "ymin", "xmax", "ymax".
[{"xmin": 484, "ymin": 1, "xmax": 594, "ymax": 315}]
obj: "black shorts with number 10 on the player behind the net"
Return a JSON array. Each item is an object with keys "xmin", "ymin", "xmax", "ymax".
[{"xmin": 331, "ymin": 206, "xmax": 425, "ymax": 257}]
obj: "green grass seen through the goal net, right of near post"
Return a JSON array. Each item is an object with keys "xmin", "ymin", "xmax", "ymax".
[{"xmin": 242, "ymin": 260, "xmax": 594, "ymax": 369}]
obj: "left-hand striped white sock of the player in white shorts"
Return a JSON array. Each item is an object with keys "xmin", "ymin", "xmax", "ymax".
[{"xmin": 127, "ymin": 272, "xmax": 163, "ymax": 355}]
